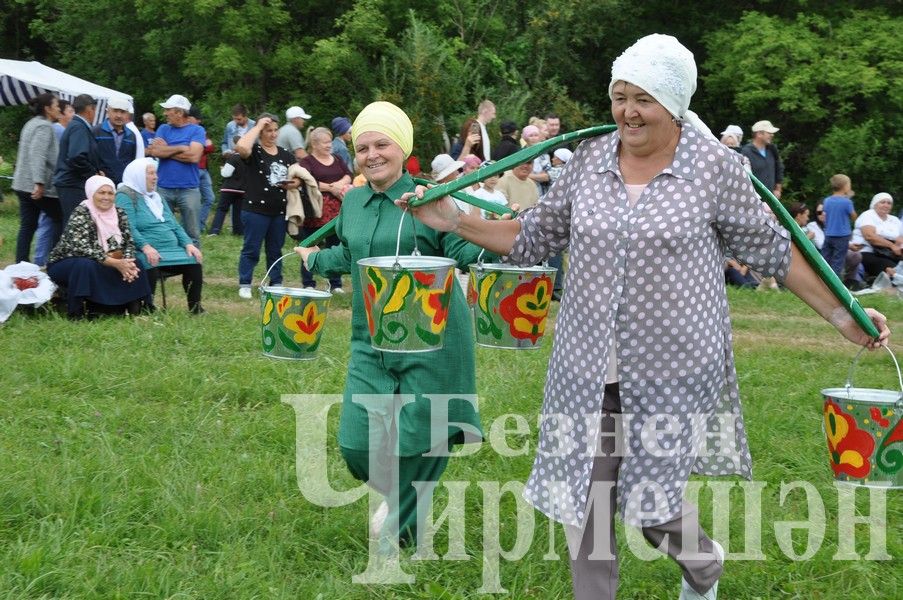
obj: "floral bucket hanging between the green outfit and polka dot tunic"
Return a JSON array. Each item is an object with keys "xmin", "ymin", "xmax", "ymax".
[{"xmin": 467, "ymin": 263, "xmax": 557, "ymax": 350}]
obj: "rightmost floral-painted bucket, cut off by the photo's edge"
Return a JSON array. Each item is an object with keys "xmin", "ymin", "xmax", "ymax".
[{"xmin": 822, "ymin": 348, "xmax": 903, "ymax": 488}]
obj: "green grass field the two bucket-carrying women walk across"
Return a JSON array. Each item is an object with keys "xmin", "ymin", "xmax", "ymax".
[{"xmin": 0, "ymin": 197, "xmax": 903, "ymax": 600}]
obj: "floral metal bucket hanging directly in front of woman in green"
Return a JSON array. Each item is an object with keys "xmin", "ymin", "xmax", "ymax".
[{"xmin": 357, "ymin": 256, "xmax": 457, "ymax": 352}]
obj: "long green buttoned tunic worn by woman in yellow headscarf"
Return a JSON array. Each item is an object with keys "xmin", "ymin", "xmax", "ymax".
[{"xmin": 308, "ymin": 173, "xmax": 482, "ymax": 456}]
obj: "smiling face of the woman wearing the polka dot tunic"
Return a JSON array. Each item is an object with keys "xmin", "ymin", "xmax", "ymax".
[{"xmin": 611, "ymin": 81, "xmax": 680, "ymax": 156}]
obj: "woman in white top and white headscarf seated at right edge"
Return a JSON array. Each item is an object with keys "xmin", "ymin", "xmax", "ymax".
[{"xmin": 852, "ymin": 192, "xmax": 903, "ymax": 280}]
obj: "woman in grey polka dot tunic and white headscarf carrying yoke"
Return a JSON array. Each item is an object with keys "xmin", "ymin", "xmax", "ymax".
[{"xmin": 401, "ymin": 34, "xmax": 889, "ymax": 600}]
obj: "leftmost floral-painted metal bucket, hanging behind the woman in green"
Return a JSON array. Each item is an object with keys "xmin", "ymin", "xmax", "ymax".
[{"xmin": 259, "ymin": 252, "xmax": 332, "ymax": 360}]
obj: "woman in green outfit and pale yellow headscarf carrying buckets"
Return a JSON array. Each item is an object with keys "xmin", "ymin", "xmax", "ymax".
[{"xmin": 295, "ymin": 102, "xmax": 482, "ymax": 543}]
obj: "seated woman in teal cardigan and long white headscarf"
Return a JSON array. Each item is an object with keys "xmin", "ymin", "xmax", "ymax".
[{"xmin": 116, "ymin": 158, "xmax": 204, "ymax": 314}]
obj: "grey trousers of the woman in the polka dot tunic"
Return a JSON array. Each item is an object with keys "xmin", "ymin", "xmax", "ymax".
[{"xmin": 565, "ymin": 383, "xmax": 722, "ymax": 600}]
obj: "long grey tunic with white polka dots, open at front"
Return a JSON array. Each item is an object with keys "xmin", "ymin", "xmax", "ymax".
[{"xmin": 505, "ymin": 124, "xmax": 790, "ymax": 526}]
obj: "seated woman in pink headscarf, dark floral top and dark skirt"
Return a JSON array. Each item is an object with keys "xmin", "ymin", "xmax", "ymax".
[{"xmin": 47, "ymin": 175, "xmax": 150, "ymax": 319}]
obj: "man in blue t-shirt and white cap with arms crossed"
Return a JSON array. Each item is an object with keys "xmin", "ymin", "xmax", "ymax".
[{"xmin": 146, "ymin": 94, "xmax": 207, "ymax": 246}]
